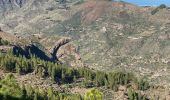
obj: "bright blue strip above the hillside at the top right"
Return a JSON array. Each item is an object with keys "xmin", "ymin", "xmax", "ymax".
[{"xmin": 119, "ymin": 0, "xmax": 170, "ymax": 7}]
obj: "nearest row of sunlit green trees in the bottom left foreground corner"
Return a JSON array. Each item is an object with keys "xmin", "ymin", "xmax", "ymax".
[{"xmin": 0, "ymin": 74, "xmax": 82, "ymax": 100}]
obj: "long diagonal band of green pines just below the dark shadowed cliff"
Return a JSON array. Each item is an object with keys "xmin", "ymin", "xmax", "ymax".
[{"xmin": 0, "ymin": 53, "xmax": 149, "ymax": 90}]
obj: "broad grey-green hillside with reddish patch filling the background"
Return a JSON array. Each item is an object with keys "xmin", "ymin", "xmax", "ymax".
[{"xmin": 0, "ymin": 0, "xmax": 170, "ymax": 85}]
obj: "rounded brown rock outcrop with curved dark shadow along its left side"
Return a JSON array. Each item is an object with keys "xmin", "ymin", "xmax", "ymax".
[{"xmin": 51, "ymin": 38, "xmax": 83, "ymax": 67}]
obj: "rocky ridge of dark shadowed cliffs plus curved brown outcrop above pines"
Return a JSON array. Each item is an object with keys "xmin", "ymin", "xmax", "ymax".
[{"xmin": 13, "ymin": 38, "xmax": 83, "ymax": 66}]
